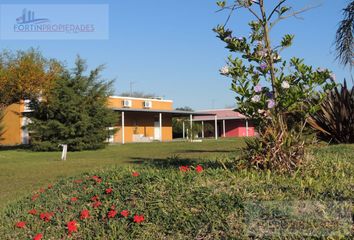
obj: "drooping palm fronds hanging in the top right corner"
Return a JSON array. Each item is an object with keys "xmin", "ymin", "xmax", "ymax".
[{"xmin": 335, "ymin": 1, "xmax": 354, "ymax": 67}]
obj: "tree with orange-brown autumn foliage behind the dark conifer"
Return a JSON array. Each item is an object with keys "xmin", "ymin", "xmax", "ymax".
[{"xmin": 0, "ymin": 49, "xmax": 62, "ymax": 110}]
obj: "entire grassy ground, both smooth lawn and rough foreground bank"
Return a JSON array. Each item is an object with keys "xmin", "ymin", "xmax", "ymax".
[{"xmin": 0, "ymin": 139, "xmax": 354, "ymax": 240}]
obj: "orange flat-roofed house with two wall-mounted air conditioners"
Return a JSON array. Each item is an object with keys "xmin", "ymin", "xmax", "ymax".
[{"xmin": 108, "ymin": 96, "xmax": 212, "ymax": 143}]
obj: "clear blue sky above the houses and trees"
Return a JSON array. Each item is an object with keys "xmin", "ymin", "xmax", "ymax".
[{"xmin": 0, "ymin": 0, "xmax": 350, "ymax": 109}]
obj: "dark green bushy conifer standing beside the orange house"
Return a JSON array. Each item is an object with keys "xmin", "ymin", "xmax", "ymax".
[{"xmin": 28, "ymin": 57, "xmax": 118, "ymax": 151}]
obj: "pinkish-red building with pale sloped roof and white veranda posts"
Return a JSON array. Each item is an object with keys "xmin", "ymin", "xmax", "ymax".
[{"xmin": 193, "ymin": 109, "xmax": 255, "ymax": 138}]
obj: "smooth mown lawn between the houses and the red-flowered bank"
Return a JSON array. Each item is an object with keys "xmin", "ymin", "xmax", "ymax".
[{"xmin": 0, "ymin": 139, "xmax": 243, "ymax": 208}]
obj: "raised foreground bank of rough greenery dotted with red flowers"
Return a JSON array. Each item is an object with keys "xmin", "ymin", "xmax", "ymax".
[{"xmin": 0, "ymin": 146, "xmax": 354, "ymax": 239}]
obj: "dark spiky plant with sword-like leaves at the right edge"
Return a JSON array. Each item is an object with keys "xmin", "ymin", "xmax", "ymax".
[{"xmin": 308, "ymin": 80, "xmax": 354, "ymax": 143}]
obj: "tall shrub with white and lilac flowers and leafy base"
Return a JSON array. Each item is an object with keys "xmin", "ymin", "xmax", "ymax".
[{"xmin": 214, "ymin": 0, "xmax": 335, "ymax": 171}]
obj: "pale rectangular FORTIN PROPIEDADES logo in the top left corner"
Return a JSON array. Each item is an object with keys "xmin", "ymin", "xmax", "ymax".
[{"xmin": 0, "ymin": 3, "xmax": 109, "ymax": 39}]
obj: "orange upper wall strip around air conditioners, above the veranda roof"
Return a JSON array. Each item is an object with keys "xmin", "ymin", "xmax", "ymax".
[{"xmin": 108, "ymin": 97, "xmax": 173, "ymax": 110}]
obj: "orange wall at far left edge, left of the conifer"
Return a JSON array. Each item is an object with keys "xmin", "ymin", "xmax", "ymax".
[{"xmin": 0, "ymin": 103, "xmax": 24, "ymax": 145}]
